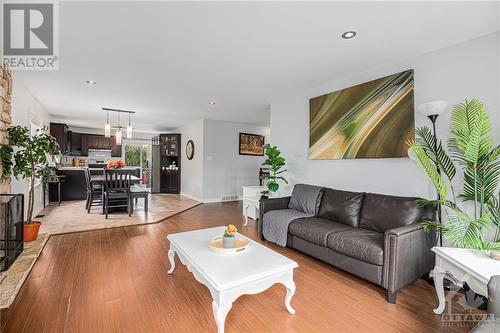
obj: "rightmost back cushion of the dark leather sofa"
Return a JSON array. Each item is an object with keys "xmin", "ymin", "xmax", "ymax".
[{"xmin": 359, "ymin": 193, "xmax": 424, "ymax": 232}]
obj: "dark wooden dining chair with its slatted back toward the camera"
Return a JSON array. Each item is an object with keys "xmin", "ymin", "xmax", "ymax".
[{"xmin": 104, "ymin": 169, "xmax": 132, "ymax": 218}]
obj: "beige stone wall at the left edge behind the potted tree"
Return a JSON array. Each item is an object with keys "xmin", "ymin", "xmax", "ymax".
[{"xmin": 0, "ymin": 64, "xmax": 12, "ymax": 193}]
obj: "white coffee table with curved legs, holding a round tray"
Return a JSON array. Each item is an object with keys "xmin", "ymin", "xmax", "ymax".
[{"xmin": 167, "ymin": 227, "xmax": 298, "ymax": 333}]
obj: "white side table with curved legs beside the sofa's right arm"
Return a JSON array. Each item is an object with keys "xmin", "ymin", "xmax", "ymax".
[{"xmin": 432, "ymin": 247, "xmax": 500, "ymax": 314}]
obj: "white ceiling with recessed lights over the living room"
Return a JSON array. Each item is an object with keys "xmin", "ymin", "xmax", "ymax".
[{"xmin": 16, "ymin": 1, "xmax": 499, "ymax": 132}]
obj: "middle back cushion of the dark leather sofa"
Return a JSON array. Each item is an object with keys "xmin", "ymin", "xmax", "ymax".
[{"xmin": 318, "ymin": 188, "xmax": 364, "ymax": 227}]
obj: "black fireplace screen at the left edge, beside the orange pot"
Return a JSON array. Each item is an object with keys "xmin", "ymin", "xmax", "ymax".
[{"xmin": 0, "ymin": 194, "xmax": 24, "ymax": 272}]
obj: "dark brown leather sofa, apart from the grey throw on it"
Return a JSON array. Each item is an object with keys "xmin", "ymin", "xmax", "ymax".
[{"xmin": 258, "ymin": 185, "xmax": 436, "ymax": 303}]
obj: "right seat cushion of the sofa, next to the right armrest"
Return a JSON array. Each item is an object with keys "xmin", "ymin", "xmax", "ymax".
[{"xmin": 327, "ymin": 228, "xmax": 384, "ymax": 266}]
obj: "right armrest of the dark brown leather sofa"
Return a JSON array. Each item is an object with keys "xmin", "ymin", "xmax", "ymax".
[{"xmin": 382, "ymin": 221, "xmax": 436, "ymax": 293}]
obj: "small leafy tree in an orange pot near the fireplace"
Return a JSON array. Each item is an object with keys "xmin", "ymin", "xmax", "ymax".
[{"xmin": 0, "ymin": 125, "xmax": 61, "ymax": 242}]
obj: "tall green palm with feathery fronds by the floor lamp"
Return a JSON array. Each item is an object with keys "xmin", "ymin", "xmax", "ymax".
[{"xmin": 408, "ymin": 99, "xmax": 500, "ymax": 250}]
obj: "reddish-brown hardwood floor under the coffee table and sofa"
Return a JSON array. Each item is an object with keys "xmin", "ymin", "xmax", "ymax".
[{"xmin": 2, "ymin": 203, "xmax": 482, "ymax": 333}]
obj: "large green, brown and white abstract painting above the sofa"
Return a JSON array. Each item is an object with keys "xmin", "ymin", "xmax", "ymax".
[{"xmin": 309, "ymin": 70, "xmax": 415, "ymax": 160}]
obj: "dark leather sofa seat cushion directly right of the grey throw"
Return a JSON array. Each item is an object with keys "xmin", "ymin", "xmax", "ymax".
[{"xmin": 288, "ymin": 217, "xmax": 352, "ymax": 246}]
